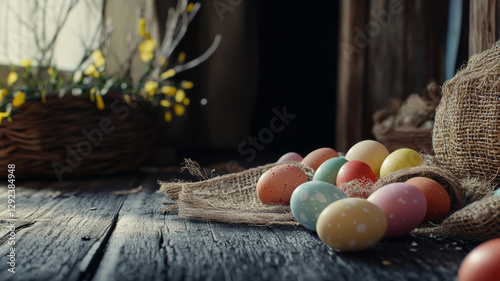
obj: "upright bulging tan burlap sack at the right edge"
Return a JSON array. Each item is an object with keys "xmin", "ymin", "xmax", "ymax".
[{"xmin": 433, "ymin": 41, "xmax": 500, "ymax": 183}]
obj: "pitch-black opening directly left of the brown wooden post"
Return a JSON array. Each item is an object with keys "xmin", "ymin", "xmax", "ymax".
[{"xmin": 252, "ymin": 0, "xmax": 339, "ymax": 154}]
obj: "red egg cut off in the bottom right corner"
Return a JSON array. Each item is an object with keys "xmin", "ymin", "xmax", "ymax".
[{"xmin": 457, "ymin": 238, "xmax": 500, "ymax": 281}]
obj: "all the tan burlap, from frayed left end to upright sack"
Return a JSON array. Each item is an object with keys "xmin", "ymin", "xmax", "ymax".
[{"xmin": 158, "ymin": 41, "xmax": 500, "ymax": 241}]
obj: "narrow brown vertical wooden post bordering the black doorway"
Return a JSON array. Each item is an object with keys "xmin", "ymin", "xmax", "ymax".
[{"xmin": 335, "ymin": 0, "xmax": 368, "ymax": 152}]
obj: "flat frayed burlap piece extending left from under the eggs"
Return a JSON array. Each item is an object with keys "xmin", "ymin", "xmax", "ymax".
[{"xmin": 158, "ymin": 160, "xmax": 314, "ymax": 225}]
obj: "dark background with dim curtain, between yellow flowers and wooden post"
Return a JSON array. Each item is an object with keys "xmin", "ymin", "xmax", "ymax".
[{"xmin": 156, "ymin": 0, "xmax": 339, "ymax": 160}]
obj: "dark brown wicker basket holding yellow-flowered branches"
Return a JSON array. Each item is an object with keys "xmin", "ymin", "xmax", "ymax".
[{"xmin": 0, "ymin": 92, "xmax": 155, "ymax": 181}]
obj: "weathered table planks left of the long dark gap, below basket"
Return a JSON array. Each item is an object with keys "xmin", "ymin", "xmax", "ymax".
[{"xmin": 0, "ymin": 175, "xmax": 137, "ymax": 281}]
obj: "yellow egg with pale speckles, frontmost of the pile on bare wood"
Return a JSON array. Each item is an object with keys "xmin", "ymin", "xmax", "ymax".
[{"xmin": 316, "ymin": 198, "xmax": 387, "ymax": 252}]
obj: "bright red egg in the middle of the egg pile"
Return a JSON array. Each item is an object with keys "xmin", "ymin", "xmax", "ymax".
[{"xmin": 337, "ymin": 160, "xmax": 378, "ymax": 187}]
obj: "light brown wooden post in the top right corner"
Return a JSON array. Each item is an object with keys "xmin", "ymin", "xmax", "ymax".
[{"xmin": 469, "ymin": 0, "xmax": 500, "ymax": 56}]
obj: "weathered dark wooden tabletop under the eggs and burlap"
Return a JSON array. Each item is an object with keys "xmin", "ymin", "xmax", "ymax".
[{"xmin": 0, "ymin": 160, "xmax": 478, "ymax": 281}]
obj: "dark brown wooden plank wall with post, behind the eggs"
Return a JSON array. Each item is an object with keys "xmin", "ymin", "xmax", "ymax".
[{"xmin": 336, "ymin": 0, "xmax": 448, "ymax": 151}]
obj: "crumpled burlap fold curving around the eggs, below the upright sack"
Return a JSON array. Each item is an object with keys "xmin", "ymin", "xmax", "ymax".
[{"xmin": 373, "ymin": 156, "xmax": 500, "ymax": 241}]
